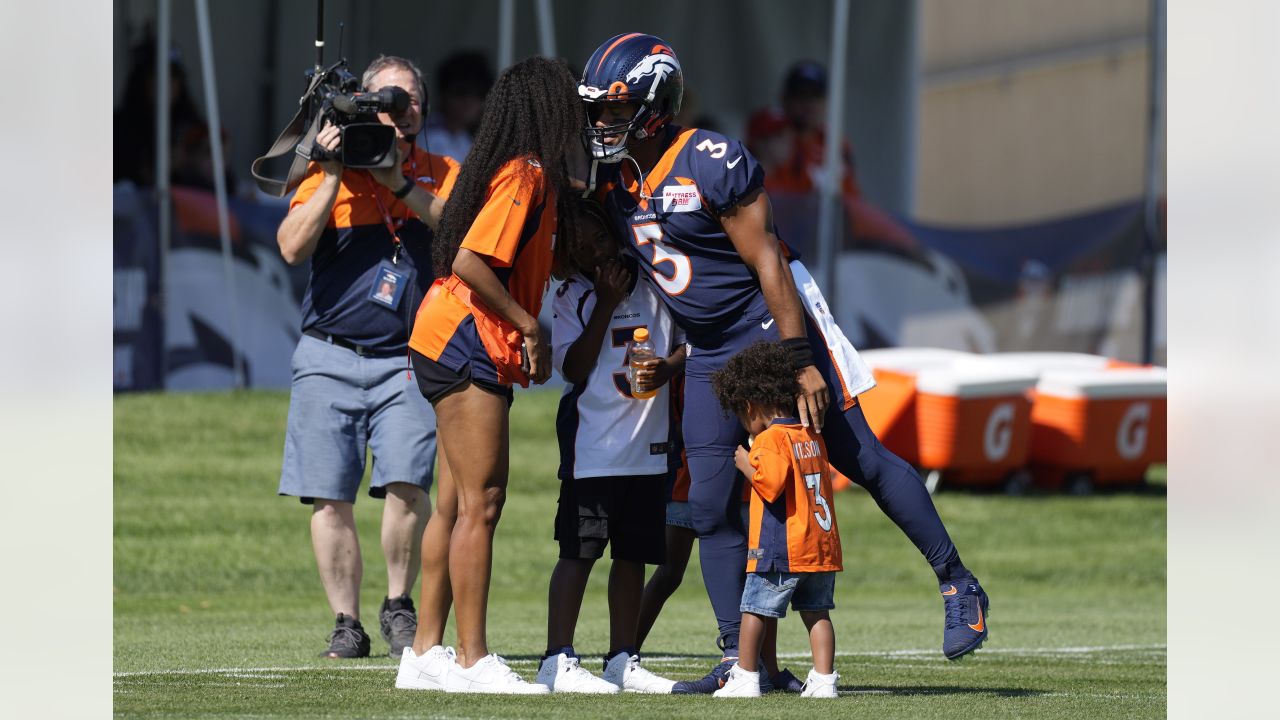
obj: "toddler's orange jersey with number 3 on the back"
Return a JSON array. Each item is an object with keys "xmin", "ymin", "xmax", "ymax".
[{"xmin": 746, "ymin": 418, "xmax": 842, "ymax": 573}]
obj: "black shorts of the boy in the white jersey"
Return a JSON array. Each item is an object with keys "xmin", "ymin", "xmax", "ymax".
[{"xmin": 556, "ymin": 475, "xmax": 667, "ymax": 565}]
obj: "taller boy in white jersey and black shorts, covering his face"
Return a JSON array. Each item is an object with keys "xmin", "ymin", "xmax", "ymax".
[{"xmin": 538, "ymin": 202, "xmax": 685, "ymax": 693}]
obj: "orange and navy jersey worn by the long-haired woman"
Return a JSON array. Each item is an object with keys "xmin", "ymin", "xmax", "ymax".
[{"xmin": 408, "ymin": 158, "xmax": 556, "ymax": 382}]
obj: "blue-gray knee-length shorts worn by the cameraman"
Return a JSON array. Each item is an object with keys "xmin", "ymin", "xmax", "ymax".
[{"xmin": 279, "ymin": 336, "xmax": 435, "ymax": 502}]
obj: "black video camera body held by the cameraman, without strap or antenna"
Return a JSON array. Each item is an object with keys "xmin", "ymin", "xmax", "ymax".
[{"xmin": 298, "ymin": 59, "xmax": 410, "ymax": 168}]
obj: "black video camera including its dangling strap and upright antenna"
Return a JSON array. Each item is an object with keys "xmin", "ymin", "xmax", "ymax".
[{"xmin": 250, "ymin": 0, "xmax": 410, "ymax": 197}]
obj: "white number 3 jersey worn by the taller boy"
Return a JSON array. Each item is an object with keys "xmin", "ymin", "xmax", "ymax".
[{"xmin": 552, "ymin": 274, "xmax": 685, "ymax": 479}]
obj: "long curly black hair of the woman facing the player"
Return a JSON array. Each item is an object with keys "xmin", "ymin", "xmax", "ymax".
[{"xmin": 431, "ymin": 58, "xmax": 586, "ymax": 275}]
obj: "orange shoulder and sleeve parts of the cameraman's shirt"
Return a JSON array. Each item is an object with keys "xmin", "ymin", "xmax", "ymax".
[{"xmin": 289, "ymin": 147, "xmax": 460, "ymax": 228}]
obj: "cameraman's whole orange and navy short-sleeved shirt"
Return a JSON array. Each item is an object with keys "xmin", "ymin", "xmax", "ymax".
[{"xmin": 289, "ymin": 147, "xmax": 458, "ymax": 355}]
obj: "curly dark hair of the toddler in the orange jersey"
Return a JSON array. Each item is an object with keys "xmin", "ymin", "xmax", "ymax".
[{"xmin": 712, "ymin": 341, "xmax": 800, "ymax": 416}]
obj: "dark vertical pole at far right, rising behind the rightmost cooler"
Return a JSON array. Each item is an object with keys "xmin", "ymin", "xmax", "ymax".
[{"xmin": 1142, "ymin": 0, "xmax": 1165, "ymax": 365}]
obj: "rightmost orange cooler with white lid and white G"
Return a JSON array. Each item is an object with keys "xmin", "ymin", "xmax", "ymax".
[{"xmin": 1029, "ymin": 366, "xmax": 1169, "ymax": 495}]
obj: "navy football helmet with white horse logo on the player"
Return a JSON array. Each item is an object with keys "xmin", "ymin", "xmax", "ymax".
[{"xmin": 577, "ymin": 32, "xmax": 685, "ymax": 163}]
